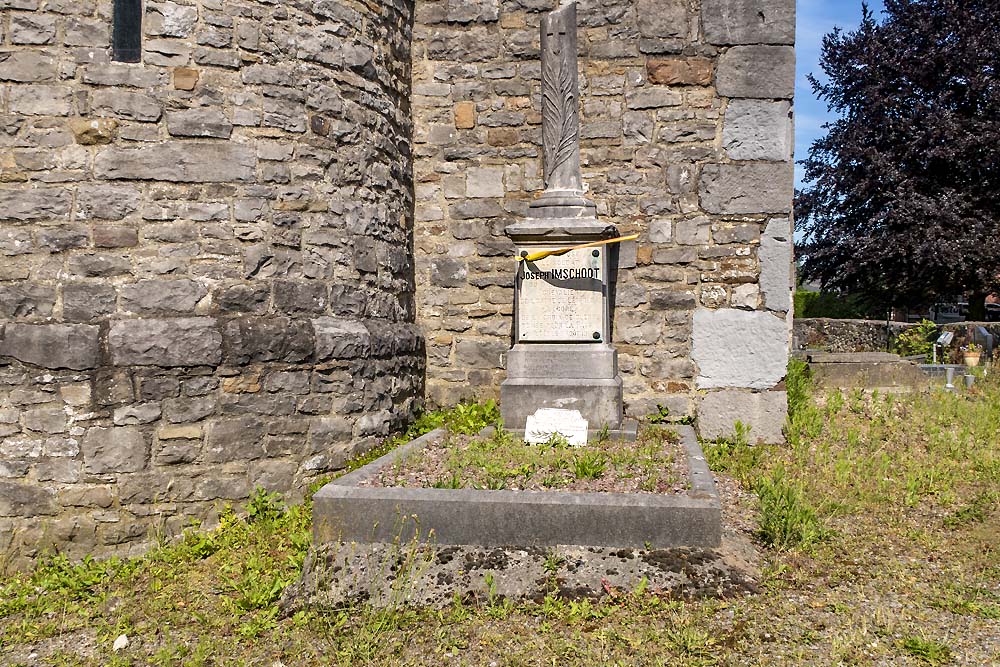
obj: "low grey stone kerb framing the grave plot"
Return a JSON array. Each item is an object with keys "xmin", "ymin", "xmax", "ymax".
[{"xmin": 313, "ymin": 427, "xmax": 721, "ymax": 548}]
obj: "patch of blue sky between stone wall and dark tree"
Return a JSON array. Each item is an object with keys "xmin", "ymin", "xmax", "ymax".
[{"xmin": 795, "ymin": 0, "xmax": 882, "ymax": 187}]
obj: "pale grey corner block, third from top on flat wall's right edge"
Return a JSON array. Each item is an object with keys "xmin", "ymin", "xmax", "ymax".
[{"xmin": 722, "ymin": 99, "xmax": 794, "ymax": 162}]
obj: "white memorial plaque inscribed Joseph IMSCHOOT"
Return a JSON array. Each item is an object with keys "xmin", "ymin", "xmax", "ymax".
[{"xmin": 517, "ymin": 248, "xmax": 605, "ymax": 343}]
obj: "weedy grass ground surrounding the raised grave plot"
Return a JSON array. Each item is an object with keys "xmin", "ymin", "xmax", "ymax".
[{"xmin": 0, "ymin": 374, "xmax": 1000, "ymax": 667}]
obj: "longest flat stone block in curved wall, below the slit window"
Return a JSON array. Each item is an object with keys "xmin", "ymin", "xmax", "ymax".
[{"xmin": 94, "ymin": 142, "xmax": 257, "ymax": 183}]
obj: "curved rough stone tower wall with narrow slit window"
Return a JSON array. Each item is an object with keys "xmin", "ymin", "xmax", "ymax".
[{"xmin": 0, "ymin": 0, "xmax": 424, "ymax": 568}]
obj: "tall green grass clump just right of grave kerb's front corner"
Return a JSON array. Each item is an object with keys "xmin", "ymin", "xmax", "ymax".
[{"xmin": 754, "ymin": 466, "xmax": 827, "ymax": 549}]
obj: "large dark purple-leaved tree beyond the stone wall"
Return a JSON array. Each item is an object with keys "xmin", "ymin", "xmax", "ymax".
[{"xmin": 796, "ymin": 0, "xmax": 1000, "ymax": 319}]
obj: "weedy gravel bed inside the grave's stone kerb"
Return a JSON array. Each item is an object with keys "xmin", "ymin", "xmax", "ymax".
[{"xmin": 361, "ymin": 428, "xmax": 689, "ymax": 494}]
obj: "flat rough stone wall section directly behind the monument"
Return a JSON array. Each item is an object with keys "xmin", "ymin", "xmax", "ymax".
[{"xmin": 413, "ymin": 0, "xmax": 795, "ymax": 440}]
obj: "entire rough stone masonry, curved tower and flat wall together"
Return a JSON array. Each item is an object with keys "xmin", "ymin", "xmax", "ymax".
[{"xmin": 0, "ymin": 0, "xmax": 794, "ymax": 559}]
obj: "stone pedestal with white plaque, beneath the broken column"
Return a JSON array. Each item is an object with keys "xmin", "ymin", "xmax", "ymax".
[{"xmin": 500, "ymin": 217, "xmax": 622, "ymax": 431}]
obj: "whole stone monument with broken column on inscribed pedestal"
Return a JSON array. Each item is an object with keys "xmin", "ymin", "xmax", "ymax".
[{"xmin": 500, "ymin": 3, "xmax": 622, "ymax": 438}]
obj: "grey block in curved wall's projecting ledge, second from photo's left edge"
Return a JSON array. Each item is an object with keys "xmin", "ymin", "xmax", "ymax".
[{"xmin": 108, "ymin": 317, "xmax": 222, "ymax": 367}]
